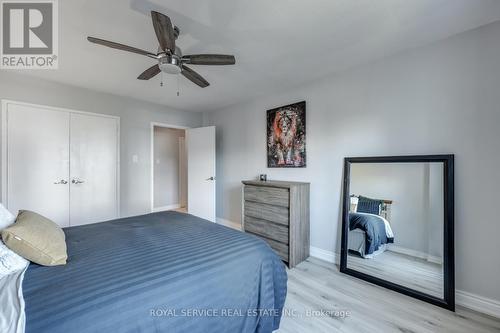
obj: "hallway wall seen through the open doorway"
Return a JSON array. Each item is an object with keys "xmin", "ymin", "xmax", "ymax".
[{"xmin": 153, "ymin": 126, "xmax": 186, "ymax": 208}]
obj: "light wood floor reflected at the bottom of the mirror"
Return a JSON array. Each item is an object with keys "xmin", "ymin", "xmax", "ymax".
[{"xmin": 347, "ymin": 251, "xmax": 444, "ymax": 298}]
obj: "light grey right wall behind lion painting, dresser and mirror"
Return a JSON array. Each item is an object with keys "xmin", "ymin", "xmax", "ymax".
[{"xmin": 204, "ymin": 22, "xmax": 500, "ymax": 300}]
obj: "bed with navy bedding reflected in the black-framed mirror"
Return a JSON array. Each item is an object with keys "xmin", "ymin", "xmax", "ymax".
[{"xmin": 348, "ymin": 195, "xmax": 394, "ymax": 259}]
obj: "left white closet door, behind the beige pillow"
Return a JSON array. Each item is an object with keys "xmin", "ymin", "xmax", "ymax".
[{"xmin": 5, "ymin": 104, "xmax": 69, "ymax": 227}]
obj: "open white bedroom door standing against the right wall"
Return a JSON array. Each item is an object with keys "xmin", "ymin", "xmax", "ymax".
[{"xmin": 186, "ymin": 126, "xmax": 215, "ymax": 222}]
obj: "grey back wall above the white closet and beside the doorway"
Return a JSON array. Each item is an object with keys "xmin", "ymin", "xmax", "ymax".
[{"xmin": 0, "ymin": 71, "xmax": 202, "ymax": 216}]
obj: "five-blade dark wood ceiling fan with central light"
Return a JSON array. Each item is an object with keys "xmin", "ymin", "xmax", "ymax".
[{"xmin": 87, "ymin": 11, "xmax": 236, "ymax": 88}]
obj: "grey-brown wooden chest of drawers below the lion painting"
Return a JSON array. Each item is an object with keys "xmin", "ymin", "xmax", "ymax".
[{"xmin": 241, "ymin": 180, "xmax": 309, "ymax": 268}]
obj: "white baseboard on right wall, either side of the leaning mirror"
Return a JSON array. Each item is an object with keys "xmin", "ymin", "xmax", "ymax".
[{"xmin": 310, "ymin": 246, "xmax": 500, "ymax": 318}]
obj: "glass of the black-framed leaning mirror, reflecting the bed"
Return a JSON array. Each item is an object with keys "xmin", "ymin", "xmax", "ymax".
[{"xmin": 347, "ymin": 163, "xmax": 444, "ymax": 298}]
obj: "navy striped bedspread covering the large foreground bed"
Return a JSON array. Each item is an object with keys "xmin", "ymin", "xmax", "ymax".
[{"xmin": 23, "ymin": 212, "xmax": 287, "ymax": 333}]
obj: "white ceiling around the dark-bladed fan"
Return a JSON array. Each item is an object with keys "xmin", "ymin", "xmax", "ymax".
[{"xmin": 13, "ymin": 0, "xmax": 500, "ymax": 111}]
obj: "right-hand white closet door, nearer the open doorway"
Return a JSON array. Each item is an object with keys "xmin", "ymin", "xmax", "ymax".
[{"xmin": 70, "ymin": 113, "xmax": 118, "ymax": 225}]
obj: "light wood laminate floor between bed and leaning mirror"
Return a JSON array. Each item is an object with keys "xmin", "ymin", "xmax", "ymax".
[{"xmin": 276, "ymin": 258, "xmax": 500, "ymax": 333}]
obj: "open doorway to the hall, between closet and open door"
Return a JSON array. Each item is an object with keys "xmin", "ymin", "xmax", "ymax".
[{"xmin": 151, "ymin": 123, "xmax": 188, "ymax": 212}]
